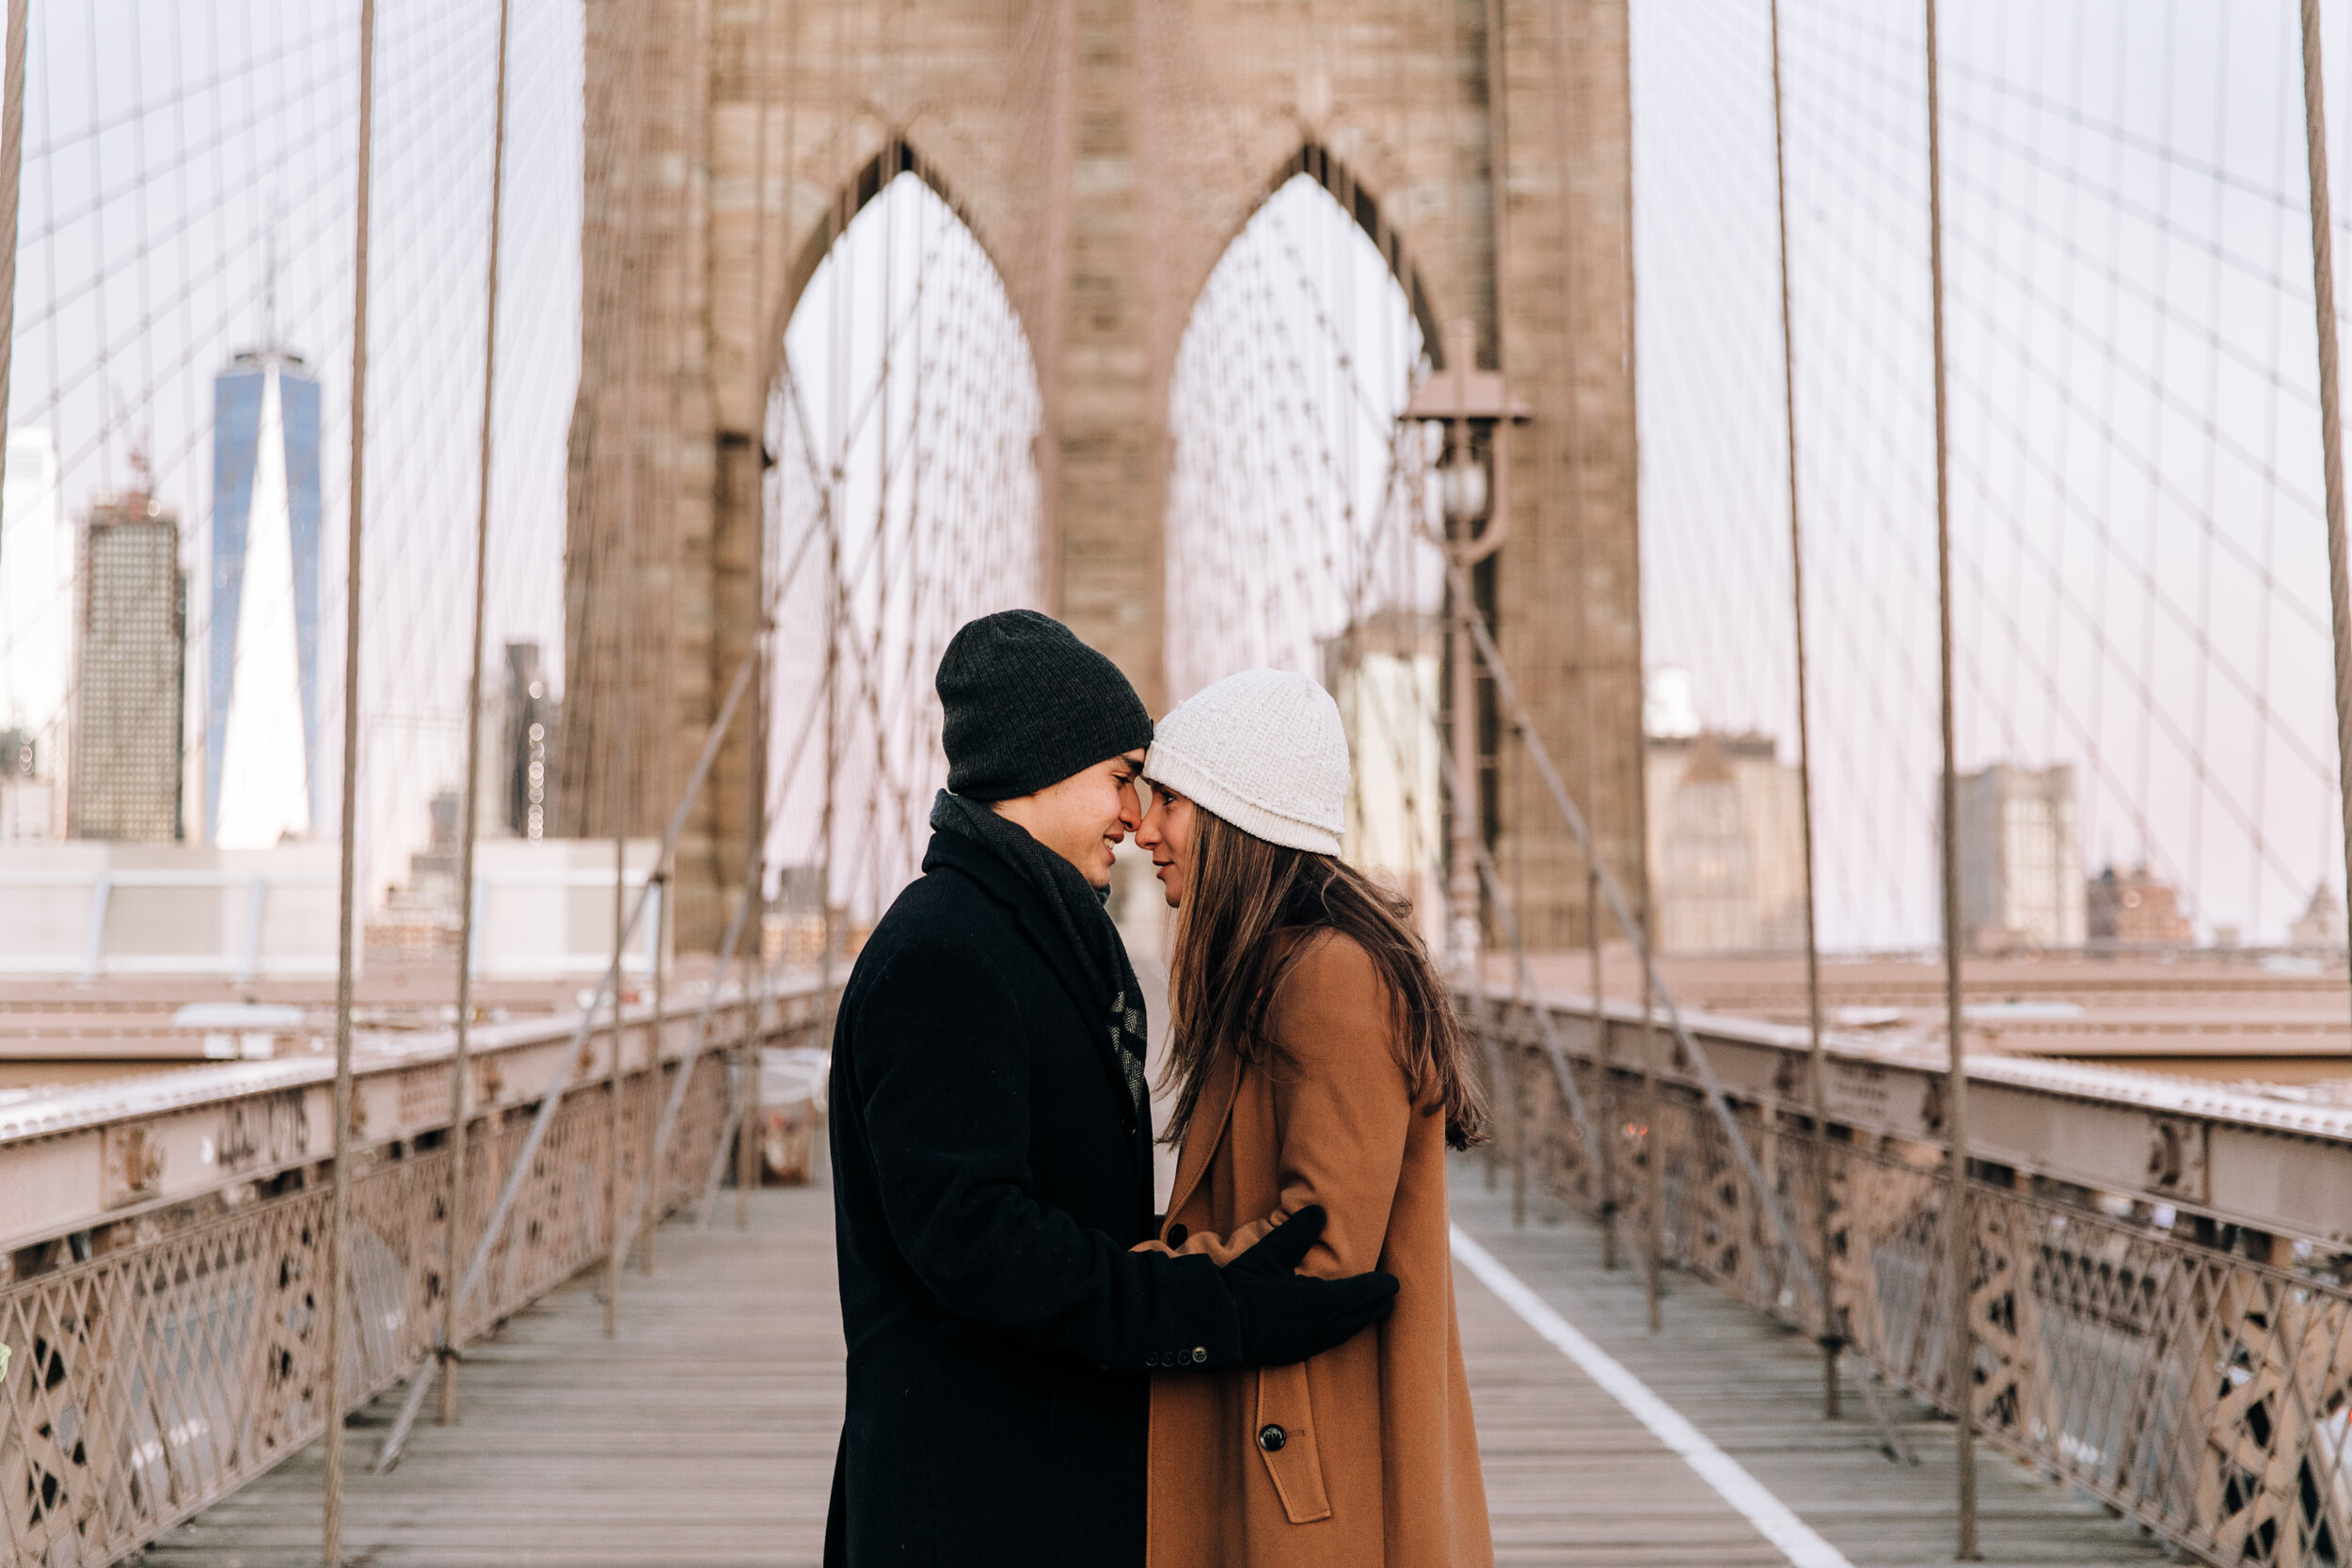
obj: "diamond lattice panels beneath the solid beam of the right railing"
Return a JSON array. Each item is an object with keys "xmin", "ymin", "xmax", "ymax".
[{"xmin": 1472, "ymin": 1004, "xmax": 2352, "ymax": 1568}]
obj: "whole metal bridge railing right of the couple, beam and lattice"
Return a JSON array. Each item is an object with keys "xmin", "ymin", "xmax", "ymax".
[{"xmin": 1470, "ymin": 999, "xmax": 2352, "ymax": 1568}]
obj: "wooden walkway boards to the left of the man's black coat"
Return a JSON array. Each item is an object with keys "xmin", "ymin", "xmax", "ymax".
[{"xmin": 146, "ymin": 1187, "xmax": 842, "ymax": 1568}]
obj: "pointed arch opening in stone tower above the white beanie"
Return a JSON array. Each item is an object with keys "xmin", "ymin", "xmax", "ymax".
[{"xmin": 1167, "ymin": 146, "xmax": 1442, "ymax": 912}]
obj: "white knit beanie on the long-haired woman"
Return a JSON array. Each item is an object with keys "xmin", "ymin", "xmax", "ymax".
[{"xmin": 1143, "ymin": 670, "xmax": 1348, "ymax": 856}]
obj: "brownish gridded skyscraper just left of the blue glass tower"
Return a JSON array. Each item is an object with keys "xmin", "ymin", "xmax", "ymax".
[{"xmin": 66, "ymin": 489, "xmax": 188, "ymax": 844}]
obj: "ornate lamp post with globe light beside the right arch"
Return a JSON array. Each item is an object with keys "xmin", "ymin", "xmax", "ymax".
[{"xmin": 1397, "ymin": 317, "xmax": 1527, "ymax": 985}]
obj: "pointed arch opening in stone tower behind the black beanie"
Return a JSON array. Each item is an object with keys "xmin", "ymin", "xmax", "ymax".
[{"xmin": 762, "ymin": 161, "xmax": 1040, "ymax": 930}]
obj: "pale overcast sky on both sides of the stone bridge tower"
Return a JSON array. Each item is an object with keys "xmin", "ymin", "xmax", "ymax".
[{"xmin": 0, "ymin": 0, "xmax": 2352, "ymax": 945}]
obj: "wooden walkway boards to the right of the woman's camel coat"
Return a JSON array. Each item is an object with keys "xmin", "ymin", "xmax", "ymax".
[{"xmin": 1454, "ymin": 1162, "xmax": 2169, "ymax": 1568}]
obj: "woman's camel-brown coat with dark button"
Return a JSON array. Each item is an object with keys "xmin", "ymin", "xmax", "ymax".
[{"xmin": 1146, "ymin": 931, "xmax": 1494, "ymax": 1568}]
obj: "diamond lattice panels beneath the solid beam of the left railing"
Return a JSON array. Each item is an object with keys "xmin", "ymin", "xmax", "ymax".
[{"xmin": 0, "ymin": 1053, "xmax": 732, "ymax": 1568}]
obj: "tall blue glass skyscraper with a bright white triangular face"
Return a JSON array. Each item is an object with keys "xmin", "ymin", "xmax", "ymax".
[{"xmin": 205, "ymin": 348, "xmax": 325, "ymax": 848}]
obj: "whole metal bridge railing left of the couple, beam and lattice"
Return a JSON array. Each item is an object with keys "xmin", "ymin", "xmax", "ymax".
[{"xmin": 0, "ymin": 988, "xmax": 823, "ymax": 1568}]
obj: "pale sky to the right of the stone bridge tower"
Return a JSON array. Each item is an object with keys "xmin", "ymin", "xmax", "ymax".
[{"xmin": 1635, "ymin": 0, "xmax": 2352, "ymax": 945}]
